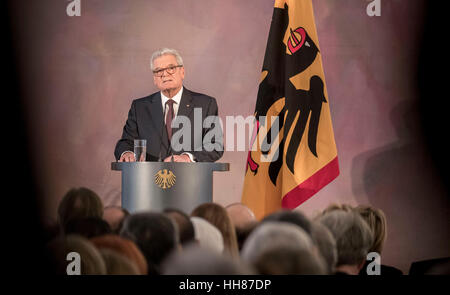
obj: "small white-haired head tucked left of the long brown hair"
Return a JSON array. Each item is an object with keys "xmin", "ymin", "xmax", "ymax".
[{"xmin": 191, "ymin": 216, "xmax": 225, "ymax": 254}]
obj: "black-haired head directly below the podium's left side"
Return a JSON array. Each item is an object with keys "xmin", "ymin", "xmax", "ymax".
[{"xmin": 120, "ymin": 212, "xmax": 178, "ymax": 274}]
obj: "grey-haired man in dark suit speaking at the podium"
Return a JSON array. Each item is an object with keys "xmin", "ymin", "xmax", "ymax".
[{"xmin": 114, "ymin": 48, "xmax": 223, "ymax": 162}]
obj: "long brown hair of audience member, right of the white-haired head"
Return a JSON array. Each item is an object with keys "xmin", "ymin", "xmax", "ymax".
[{"xmin": 191, "ymin": 203, "xmax": 239, "ymax": 259}]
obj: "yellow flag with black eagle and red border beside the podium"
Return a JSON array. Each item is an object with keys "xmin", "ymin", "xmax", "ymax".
[{"xmin": 242, "ymin": 0, "xmax": 339, "ymax": 219}]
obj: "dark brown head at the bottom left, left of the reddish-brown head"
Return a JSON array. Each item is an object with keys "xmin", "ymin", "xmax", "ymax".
[{"xmin": 47, "ymin": 235, "xmax": 106, "ymax": 275}]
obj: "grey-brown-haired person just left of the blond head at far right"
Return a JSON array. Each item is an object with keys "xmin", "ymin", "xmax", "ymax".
[{"xmin": 317, "ymin": 210, "xmax": 373, "ymax": 275}]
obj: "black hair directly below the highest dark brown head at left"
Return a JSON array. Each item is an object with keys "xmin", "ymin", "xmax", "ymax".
[{"xmin": 64, "ymin": 217, "xmax": 112, "ymax": 239}]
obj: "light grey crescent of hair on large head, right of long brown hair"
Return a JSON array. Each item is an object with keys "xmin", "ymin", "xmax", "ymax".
[{"xmin": 241, "ymin": 221, "xmax": 314, "ymax": 264}]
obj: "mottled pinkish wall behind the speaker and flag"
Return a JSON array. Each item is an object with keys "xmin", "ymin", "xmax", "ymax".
[{"xmin": 7, "ymin": 0, "xmax": 450, "ymax": 272}]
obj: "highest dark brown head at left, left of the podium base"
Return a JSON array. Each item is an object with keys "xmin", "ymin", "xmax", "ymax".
[{"xmin": 58, "ymin": 187, "xmax": 103, "ymax": 228}]
